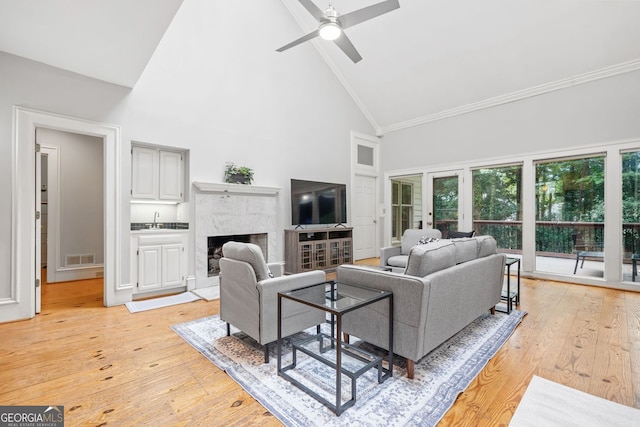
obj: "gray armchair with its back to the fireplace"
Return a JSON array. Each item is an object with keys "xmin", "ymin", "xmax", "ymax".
[{"xmin": 220, "ymin": 242, "xmax": 326, "ymax": 363}]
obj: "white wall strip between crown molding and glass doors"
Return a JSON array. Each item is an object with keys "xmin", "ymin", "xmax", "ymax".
[{"xmin": 380, "ymin": 71, "xmax": 640, "ymax": 175}]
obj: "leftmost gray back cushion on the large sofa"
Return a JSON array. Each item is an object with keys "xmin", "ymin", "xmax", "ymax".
[{"xmin": 405, "ymin": 240, "xmax": 456, "ymax": 277}]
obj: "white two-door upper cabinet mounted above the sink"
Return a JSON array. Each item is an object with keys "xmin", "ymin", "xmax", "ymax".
[{"xmin": 131, "ymin": 145, "xmax": 184, "ymax": 202}]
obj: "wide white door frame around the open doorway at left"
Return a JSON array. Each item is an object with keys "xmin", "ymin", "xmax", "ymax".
[{"xmin": 0, "ymin": 106, "xmax": 125, "ymax": 322}]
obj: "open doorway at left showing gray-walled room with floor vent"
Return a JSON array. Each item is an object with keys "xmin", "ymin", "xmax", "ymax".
[{"xmin": 36, "ymin": 128, "xmax": 104, "ymax": 312}]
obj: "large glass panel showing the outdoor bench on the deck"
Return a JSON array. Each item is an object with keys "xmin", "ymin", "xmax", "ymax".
[{"xmin": 535, "ymin": 156, "xmax": 605, "ymax": 278}]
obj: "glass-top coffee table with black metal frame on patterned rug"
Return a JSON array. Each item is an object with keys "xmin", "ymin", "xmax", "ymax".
[{"xmin": 278, "ymin": 281, "xmax": 393, "ymax": 415}]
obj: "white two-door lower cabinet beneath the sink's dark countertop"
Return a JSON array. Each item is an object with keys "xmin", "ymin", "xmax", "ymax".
[{"xmin": 131, "ymin": 231, "xmax": 188, "ymax": 293}]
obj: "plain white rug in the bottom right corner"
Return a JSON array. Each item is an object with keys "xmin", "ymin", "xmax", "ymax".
[{"xmin": 509, "ymin": 375, "xmax": 640, "ymax": 427}]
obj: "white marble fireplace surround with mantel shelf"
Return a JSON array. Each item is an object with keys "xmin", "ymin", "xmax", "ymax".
[{"xmin": 193, "ymin": 182, "xmax": 282, "ymax": 289}]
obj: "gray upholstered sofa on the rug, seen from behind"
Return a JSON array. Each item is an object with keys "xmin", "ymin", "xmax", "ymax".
[{"xmin": 337, "ymin": 236, "xmax": 505, "ymax": 378}]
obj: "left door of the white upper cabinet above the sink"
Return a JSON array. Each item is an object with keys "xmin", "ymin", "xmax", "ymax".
[{"xmin": 131, "ymin": 146, "xmax": 159, "ymax": 200}]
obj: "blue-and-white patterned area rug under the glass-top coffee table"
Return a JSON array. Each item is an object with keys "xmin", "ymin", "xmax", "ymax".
[{"xmin": 172, "ymin": 310, "xmax": 526, "ymax": 427}]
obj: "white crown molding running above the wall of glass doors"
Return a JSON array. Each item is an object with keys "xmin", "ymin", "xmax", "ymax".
[{"xmin": 381, "ymin": 58, "xmax": 640, "ymax": 134}]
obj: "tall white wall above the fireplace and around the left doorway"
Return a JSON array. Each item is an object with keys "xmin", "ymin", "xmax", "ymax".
[{"xmin": 0, "ymin": 0, "xmax": 374, "ymax": 314}]
